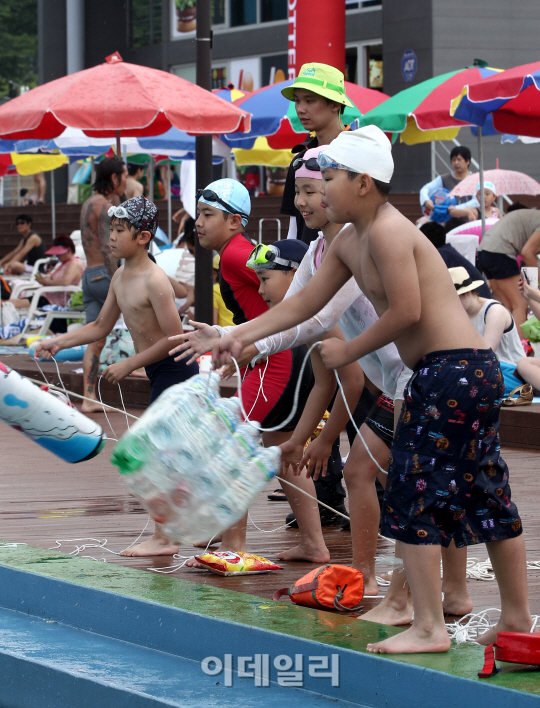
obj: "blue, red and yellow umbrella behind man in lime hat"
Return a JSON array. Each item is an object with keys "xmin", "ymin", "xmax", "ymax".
[{"xmin": 222, "ymin": 79, "xmax": 388, "ymax": 150}]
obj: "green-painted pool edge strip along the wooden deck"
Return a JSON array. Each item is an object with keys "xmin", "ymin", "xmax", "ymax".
[{"xmin": 0, "ymin": 541, "xmax": 540, "ymax": 696}]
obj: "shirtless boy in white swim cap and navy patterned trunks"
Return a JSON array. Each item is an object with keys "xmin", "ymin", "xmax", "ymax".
[{"xmin": 214, "ymin": 126, "xmax": 532, "ymax": 653}]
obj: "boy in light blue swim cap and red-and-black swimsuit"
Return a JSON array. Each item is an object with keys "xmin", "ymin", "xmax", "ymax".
[{"xmin": 171, "ymin": 179, "xmax": 330, "ymax": 566}]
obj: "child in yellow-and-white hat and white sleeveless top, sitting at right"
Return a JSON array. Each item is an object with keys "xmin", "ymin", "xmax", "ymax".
[{"xmin": 448, "ymin": 268, "xmax": 524, "ymax": 395}]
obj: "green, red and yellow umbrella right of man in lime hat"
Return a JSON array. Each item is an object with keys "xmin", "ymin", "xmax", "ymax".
[{"xmin": 360, "ymin": 66, "xmax": 500, "ymax": 145}]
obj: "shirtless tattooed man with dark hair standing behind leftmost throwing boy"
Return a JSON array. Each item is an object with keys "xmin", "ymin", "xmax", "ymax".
[{"xmin": 81, "ymin": 157, "xmax": 127, "ymax": 413}]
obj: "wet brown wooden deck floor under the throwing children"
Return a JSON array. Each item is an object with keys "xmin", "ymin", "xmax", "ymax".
[{"xmin": 0, "ymin": 410, "xmax": 540, "ymax": 614}]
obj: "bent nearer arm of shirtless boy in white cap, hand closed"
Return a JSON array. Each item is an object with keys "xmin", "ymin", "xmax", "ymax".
[{"xmin": 318, "ymin": 221, "xmax": 421, "ymax": 369}]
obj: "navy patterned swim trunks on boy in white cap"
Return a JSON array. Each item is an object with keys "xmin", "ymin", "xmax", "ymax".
[{"xmin": 381, "ymin": 349, "xmax": 522, "ymax": 548}]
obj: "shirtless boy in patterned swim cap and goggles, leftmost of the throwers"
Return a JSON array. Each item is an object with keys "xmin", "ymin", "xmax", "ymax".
[{"xmin": 35, "ymin": 197, "xmax": 199, "ymax": 556}]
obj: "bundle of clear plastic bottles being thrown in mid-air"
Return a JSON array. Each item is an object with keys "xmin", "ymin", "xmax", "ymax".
[{"xmin": 111, "ymin": 372, "xmax": 281, "ymax": 544}]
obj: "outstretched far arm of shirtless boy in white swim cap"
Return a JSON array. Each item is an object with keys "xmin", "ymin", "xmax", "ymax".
[{"xmin": 213, "ymin": 242, "xmax": 352, "ymax": 366}]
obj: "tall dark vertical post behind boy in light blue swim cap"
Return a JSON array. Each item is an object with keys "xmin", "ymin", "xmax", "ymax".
[{"xmin": 195, "ymin": 0, "xmax": 214, "ymax": 325}]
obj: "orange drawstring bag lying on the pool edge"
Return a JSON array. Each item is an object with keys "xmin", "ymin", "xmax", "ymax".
[{"xmin": 272, "ymin": 564, "xmax": 364, "ymax": 612}]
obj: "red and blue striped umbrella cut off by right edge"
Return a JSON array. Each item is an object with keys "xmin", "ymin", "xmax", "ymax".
[{"xmin": 452, "ymin": 61, "xmax": 540, "ymax": 138}]
